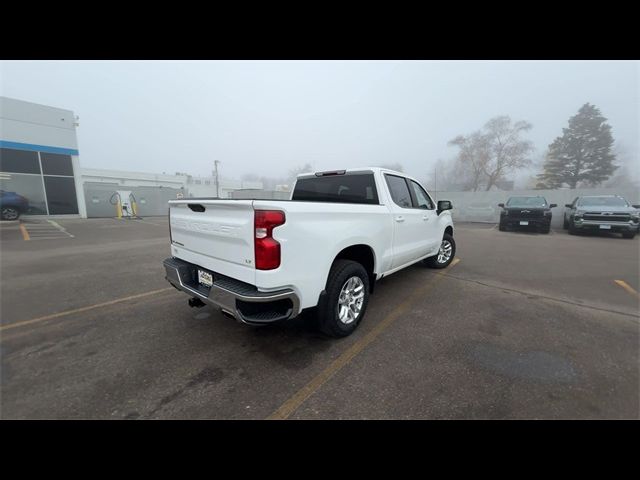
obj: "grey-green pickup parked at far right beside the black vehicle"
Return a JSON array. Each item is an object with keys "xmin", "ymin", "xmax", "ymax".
[{"xmin": 563, "ymin": 195, "xmax": 640, "ymax": 238}]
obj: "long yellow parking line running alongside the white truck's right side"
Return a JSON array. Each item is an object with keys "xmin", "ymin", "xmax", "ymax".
[{"xmin": 267, "ymin": 258, "xmax": 460, "ymax": 420}]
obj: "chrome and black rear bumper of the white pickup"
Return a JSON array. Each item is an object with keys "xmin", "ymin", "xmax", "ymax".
[{"xmin": 163, "ymin": 257, "xmax": 300, "ymax": 325}]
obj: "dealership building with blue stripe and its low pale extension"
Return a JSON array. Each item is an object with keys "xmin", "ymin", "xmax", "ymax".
[{"xmin": 0, "ymin": 97, "xmax": 262, "ymax": 218}]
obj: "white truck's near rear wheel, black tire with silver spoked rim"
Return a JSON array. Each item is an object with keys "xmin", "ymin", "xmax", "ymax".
[{"xmin": 316, "ymin": 260, "xmax": 369, "ymax": 337}]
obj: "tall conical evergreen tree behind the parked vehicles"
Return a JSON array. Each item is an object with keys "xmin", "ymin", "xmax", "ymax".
[{"xmin": 538, "ymin": 103, "xmax": 618, "ymax": 188}]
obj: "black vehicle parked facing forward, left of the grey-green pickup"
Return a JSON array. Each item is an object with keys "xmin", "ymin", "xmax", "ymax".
[{"xmin": 498, "ymin": 197, "xmax": 558, "ymax": 233}]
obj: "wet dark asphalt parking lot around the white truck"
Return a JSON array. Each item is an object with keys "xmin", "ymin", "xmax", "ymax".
[{"xmin": 0, "ymin": 218, "xmax": 640, "ymax": 419}]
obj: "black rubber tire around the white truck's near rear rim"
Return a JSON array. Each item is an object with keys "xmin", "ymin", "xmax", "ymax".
[{"xmin": 316, "ymin": 260, "xmax": 369, "ymax": 337}]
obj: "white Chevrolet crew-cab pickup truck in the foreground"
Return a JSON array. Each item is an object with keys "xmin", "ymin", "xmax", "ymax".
[{"xmin": 164, "ymin": 168, "xmax": 456, "ymax": 337}]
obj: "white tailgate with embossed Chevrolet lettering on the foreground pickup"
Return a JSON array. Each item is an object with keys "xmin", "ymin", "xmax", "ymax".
[{"xmin": 169, "ymin": 199, "xmax": 255, "ymax": 285}]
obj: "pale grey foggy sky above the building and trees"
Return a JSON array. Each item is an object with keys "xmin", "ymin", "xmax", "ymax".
[{"xmin": 0, "ymin": 61, "xmax": 640, "ymax": 182}]
